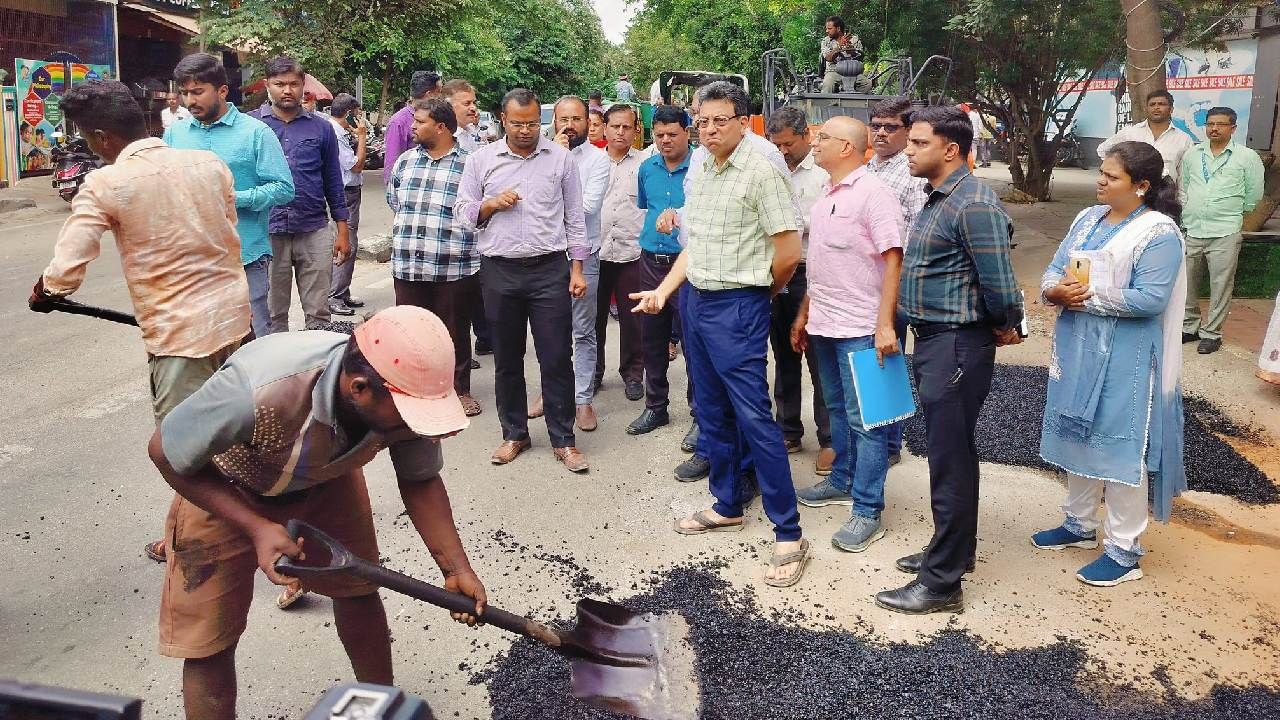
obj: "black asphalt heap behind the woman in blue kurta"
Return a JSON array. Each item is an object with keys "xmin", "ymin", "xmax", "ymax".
[{"xmin": 904, "ymin": 364, "xmax": 1280, "ymax": 503}]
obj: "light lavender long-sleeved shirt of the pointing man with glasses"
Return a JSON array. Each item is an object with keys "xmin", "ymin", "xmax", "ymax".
[{"xmin": 453, "ymin": 137, "xmax": 591, "ymax": 260}]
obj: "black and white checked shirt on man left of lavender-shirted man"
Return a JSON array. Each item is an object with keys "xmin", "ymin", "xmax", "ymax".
[{"xmin": 387, "ymin": 145, "xmax": 480, "ymax": 282}]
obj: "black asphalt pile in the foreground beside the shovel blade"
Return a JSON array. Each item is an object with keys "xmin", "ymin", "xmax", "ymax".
[{"xmin": 471, "ymin": 560, "xmax": 1280, "ymax": 720}]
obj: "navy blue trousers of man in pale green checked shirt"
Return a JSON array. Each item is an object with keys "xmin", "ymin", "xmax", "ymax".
[{"xmin": 680, "ymin": 288, "xmax": 800, "ymax": 542}]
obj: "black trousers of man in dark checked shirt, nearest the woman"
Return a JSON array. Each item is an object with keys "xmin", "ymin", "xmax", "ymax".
[{"xmin": 914, "ymin": 327, "xmax": 996, "ymax": 592}]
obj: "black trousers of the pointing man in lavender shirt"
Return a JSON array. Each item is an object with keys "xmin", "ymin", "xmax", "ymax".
[{"xmin": 480, "ymin": 252, "xmax": 575, "ymax": 447}]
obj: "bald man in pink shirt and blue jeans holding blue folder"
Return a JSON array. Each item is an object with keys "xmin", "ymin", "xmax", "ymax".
[{"xmin": 791, "ymin": 117, "xmax": 902, "ymax": 552}]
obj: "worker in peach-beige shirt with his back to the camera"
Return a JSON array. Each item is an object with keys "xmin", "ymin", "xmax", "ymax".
[{"xmin": 29, "ymin": 81, "xmax": 250, "ymax": 562}]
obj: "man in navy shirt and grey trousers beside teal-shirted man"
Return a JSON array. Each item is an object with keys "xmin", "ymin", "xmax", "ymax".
[{"xmin": 253, "ymin": 55, "xmax": 351, "ymax": 333}]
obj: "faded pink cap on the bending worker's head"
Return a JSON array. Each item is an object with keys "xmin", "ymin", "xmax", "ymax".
[{"xmin": 356, "ymin": 305, "xmax": 471, "ymax": 436}]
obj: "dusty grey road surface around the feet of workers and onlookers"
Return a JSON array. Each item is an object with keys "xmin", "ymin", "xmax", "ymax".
[{"xmin": 0, "ymin": 174, "xmax": 1280, "ymax": 719}]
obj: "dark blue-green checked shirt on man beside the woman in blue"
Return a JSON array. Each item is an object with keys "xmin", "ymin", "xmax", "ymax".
[{"xmin": 899, "ymin": 168, "xmax": 1023, "ymax": 329}]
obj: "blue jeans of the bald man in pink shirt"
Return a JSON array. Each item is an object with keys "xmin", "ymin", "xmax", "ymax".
[{"xmin": 809, "ymin": 336, "xmax": 890, "ymax": 519}]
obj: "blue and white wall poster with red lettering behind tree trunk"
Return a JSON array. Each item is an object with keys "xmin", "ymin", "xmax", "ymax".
[{"xmin": 1060, "ymin": 38, "xmax": 1258, "ymax": 142}]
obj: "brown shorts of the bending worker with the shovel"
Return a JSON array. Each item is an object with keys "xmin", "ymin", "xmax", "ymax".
[{"xmin": 160, "ymin": 470, "xmax": 379, "ymax": 659}]
